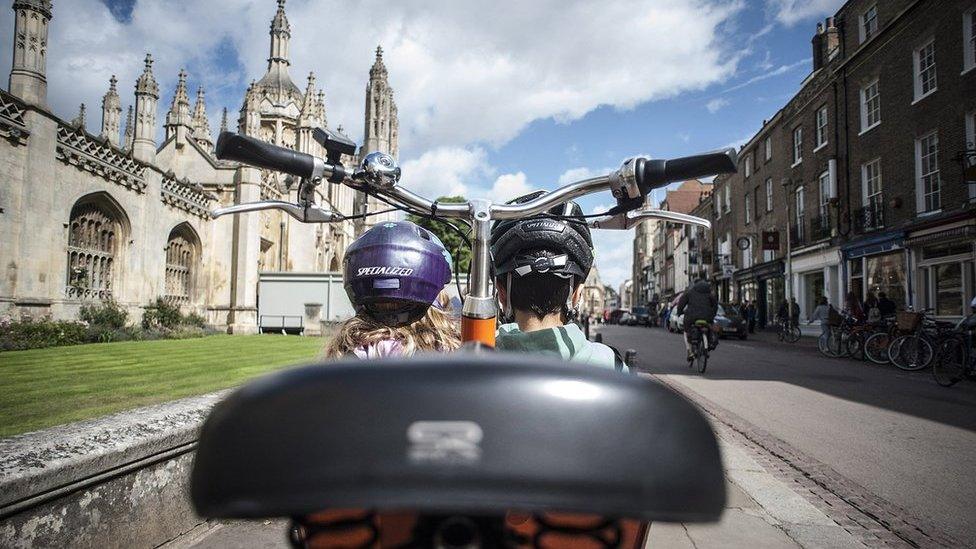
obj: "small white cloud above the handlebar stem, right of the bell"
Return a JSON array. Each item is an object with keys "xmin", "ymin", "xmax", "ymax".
[{"xmin": 401, "ymin": 147, "xmax": 488, "ymax": 199}]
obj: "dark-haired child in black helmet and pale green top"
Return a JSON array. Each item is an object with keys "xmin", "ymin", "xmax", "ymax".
[{"xmin": 491, "ymin": 191, "xmax": 623, "ymax": 369}]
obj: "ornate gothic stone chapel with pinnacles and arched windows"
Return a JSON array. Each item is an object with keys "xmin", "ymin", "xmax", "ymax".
[{"xmin": 0, "ymin": 0, "xmax": 398, "ymax": 333}]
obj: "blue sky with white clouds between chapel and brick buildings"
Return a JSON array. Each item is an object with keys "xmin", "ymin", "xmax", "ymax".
[{"xmin": 0, "ymin": 0, "xmax": 842, "ymax": 287}]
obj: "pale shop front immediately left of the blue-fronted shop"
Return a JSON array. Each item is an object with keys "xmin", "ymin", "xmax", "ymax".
[{"xmin": 793, "ymin": 246, "xmax": 844, "ymax": 319}]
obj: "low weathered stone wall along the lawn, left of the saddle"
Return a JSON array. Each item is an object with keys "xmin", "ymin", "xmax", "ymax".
[{"xmin": 0, "ymin": 391, "xmax": 228, "ymax": 548}]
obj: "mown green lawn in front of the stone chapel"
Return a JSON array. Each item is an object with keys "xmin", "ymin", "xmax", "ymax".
[{"xmin": 0, "ymin": 335, "xmax": 325, "ymax": 436}]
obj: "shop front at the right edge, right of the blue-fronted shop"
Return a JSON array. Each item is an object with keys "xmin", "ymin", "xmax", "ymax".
[{"xmin": 905, "ymin": 217, "xmax": 976, "ymax": 320}]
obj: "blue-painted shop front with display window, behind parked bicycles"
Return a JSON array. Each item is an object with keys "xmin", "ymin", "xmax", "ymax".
[{"xmin": 842, "ymin": 231, "xmax": 911, "ymax": 309}]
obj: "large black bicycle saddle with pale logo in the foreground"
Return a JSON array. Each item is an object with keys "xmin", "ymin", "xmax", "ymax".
[{"xmin": 191, "ymin": 353, "xmax": 725, "ymax": 522}]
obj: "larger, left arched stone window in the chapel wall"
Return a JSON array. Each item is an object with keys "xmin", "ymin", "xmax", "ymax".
[{"xmin": 65, "ymin": 193, "xmax": 128, "ymax": 299}]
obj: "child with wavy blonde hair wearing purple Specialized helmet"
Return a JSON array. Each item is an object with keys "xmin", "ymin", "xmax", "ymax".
[{"xmin": 325, "ymin": 221, "xmax": 461, "ymax": 358}]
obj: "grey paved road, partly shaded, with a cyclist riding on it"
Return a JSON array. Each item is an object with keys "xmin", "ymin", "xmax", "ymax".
[{"xmin": 600, "ymin": 326, "xmax": 976, "ymax": 544}]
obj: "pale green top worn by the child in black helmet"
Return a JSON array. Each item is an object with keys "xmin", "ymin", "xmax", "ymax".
[{"xmin": 495, "ymin": 323, "xmax": 626, "ymax": 369}]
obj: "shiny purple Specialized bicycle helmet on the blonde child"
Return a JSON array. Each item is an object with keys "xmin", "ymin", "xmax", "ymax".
[{"xmin": 342, "ymin": 221, "xmax": 451, "ymax": 326}]
